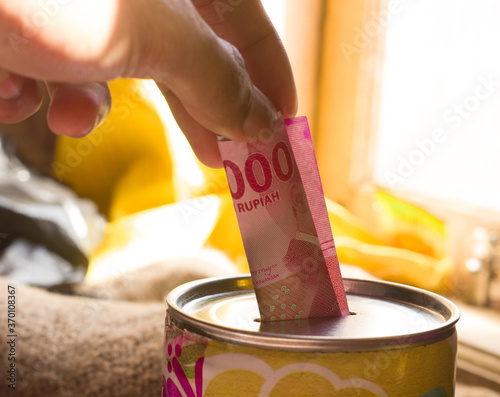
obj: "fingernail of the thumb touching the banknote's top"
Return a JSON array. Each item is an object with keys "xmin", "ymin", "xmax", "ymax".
[{"xmin": 243, "ymin": 87, "xmax": 278, "ymax": 141}]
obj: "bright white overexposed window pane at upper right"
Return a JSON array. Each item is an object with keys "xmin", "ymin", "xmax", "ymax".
[{"xmin": 374, "ymin": 0, "xmax": 500, "ymax": 217}]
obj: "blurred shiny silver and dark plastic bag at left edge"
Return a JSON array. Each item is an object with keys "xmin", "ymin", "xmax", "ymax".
[{"xmin": 0, "ymin": 135, "xmax": 106, "ymax": 287}]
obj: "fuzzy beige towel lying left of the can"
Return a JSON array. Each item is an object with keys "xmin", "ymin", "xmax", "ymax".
[{"xmin": 0, "ymin": 252, "xmax": 236, "ymax": 397}]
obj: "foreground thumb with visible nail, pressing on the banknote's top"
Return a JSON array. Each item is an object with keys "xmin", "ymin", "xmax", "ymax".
[{"xmin": 156, "ymin": 31, "xmax": 276, "ymax": 140}]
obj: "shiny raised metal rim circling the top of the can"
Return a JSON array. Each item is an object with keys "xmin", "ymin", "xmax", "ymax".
[{"xmin": 167, "ymin": 275, "xmax": 460, "ymax": 352}]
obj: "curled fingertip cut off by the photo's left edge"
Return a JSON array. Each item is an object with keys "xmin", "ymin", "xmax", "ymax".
[{"xmin": 0, "ymin": 69, "xmax": 42, "ymax": 124}]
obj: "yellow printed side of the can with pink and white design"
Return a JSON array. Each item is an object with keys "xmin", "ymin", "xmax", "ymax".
[{"xmin": 163, "ymin": 323, "xmax": 456, "ymax": 397}]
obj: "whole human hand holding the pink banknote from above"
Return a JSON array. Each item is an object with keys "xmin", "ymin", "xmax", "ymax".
[{"xmin": 0, "ymin": 0, "xmax": 297, "ymax": 167}]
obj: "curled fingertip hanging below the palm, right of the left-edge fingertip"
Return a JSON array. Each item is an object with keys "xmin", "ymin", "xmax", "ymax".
[{"xmin": 47, "ymin": 82, "xmax": 111, "ymax": 138}]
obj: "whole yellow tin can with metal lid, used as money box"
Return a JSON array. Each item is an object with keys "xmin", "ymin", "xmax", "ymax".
[{"xmin": 162, "ymin": 276, "xmax": 459, "ymax": 397}]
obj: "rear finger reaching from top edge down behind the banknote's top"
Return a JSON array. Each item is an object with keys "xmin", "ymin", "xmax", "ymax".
[{"xmin": 193, "ymin": 0, "xmax": 297, "ymax": 117}]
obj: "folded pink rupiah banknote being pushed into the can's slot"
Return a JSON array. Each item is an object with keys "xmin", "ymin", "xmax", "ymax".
[{"xmin": 219, "ymin": 117, "xmax": 349, "ymax": 321}]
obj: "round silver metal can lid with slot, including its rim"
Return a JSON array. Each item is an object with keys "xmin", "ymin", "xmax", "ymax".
[{"xmin": 167, "ymin": 276, "xmax": 459, "ymax": 352}]
